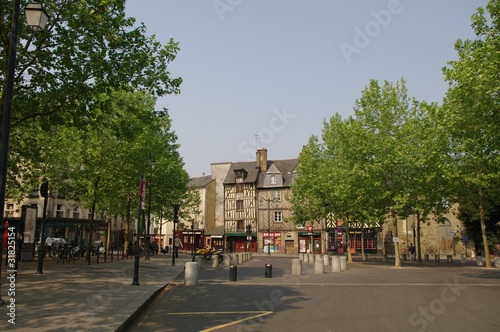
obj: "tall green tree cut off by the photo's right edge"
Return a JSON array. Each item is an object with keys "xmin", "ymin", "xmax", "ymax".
[{"xmin": 441, "ymin": 0, "xmax": 500, "ymax": 267}]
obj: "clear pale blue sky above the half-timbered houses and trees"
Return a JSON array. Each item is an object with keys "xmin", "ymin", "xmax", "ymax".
[{"xmin": 127, "ymin": 0, "xmax": 487, "ymax": 177}]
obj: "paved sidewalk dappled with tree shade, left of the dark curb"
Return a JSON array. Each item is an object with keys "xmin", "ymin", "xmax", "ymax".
[{"xmin": 0, "ymin": 254, "xmax": 191, "ymax": 331}]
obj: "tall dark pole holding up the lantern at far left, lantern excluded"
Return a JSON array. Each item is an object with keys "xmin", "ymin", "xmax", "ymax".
[{"xmin": 0, "ymin": 0, "xmax": 21, "ymax": 305}]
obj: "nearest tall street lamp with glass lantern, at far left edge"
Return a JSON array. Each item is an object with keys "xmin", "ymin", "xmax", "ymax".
[{"xmin": 0, "ymin": 0, "xmax": 49, "ymax": 305}]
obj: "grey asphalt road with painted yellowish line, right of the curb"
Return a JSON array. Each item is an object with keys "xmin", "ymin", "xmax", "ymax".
[{"xmin": 123, "ymin": 256, "xmax": 500, "ymax": 332}]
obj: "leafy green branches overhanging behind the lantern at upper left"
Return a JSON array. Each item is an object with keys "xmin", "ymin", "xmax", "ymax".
[{"xmin": 0, "ymin": 0, "xmax": 182, "ymax": 195}]
